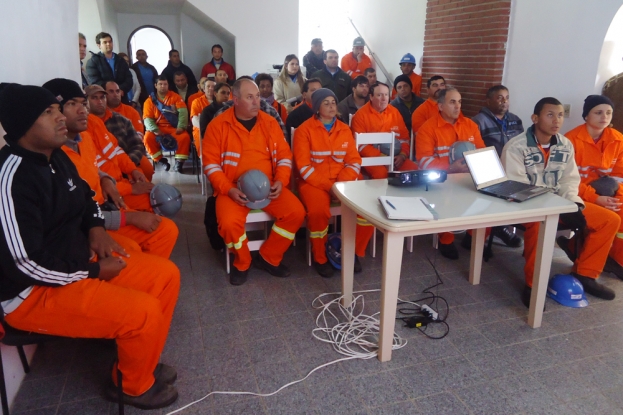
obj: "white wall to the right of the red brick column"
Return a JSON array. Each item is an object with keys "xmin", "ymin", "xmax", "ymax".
[{"xmin": 502, "ymin": 0, "xmax": 623, "ymax": 132}]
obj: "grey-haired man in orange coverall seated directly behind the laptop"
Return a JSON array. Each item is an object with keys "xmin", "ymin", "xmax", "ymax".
[{"xmin": 415, "ymin": 85, "xmax": 485, "ymax": 259}]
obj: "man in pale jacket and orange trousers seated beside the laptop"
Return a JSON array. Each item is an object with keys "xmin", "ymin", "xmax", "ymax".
[{"xmin": 502, "ymin": 97, "xmax": 621, "ymax": 307}]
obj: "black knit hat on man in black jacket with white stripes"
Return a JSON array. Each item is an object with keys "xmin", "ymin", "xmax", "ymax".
[{"xmin": 0, "ymin": 84, "xmax": 58, "ymax": 143}]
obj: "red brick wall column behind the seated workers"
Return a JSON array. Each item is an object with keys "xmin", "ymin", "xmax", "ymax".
[{"xmin": 422, "ymin": 0, "xmax": 511, "ymax": 117}]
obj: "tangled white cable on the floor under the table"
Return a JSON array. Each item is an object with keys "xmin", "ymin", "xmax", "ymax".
[{"xmin": 166, "ymin": 290, "xmax": 408, "ymax": 415}]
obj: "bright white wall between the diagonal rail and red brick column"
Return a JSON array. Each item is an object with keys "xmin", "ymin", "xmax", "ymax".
[{"xmin": 348, "ymin": 0, "xmax": 426, "ymax": 82}]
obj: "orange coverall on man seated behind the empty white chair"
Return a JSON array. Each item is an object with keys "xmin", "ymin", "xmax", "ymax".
[{"xmin": 350, "ymin": 102, "xmax": 417, "ymax": 179}]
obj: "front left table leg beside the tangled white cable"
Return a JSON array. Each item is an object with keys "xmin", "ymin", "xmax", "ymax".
[{"xmin": 378, "ymin": 232, "xmax": 404, "ymax": 362}]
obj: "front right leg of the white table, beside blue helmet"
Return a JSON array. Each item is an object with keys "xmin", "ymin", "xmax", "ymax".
[{"xmin": 528, "ymin": 215, "xmax": 558, "ymax": 328}]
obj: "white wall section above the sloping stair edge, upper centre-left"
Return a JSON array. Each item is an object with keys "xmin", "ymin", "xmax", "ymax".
[{"xmin": 188, "ymin": 0, "xmax": 300, "ymax": 76}]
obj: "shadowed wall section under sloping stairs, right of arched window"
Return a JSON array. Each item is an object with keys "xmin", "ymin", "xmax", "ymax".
[{"xmin": 180, "ymin": 13, "xmax": 236, "ymax": 81}]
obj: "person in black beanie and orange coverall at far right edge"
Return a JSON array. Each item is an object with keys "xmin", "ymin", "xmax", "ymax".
[{"xmin": 557, "ymin": 95, "xmax": 623, "ymax": 279}]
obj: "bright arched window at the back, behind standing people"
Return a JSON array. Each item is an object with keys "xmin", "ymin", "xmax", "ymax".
[{"xmin": 128, "ymin": 26, "xmax": 173, "ymax": 73}]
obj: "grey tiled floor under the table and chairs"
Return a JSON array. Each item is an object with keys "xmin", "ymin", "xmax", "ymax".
[{"xmin": 13, "ymin": 164, "xmax": 623, "ymax": 415}]
